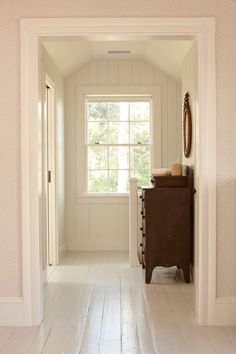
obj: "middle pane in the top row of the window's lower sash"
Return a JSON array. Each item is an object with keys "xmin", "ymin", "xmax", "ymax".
[{"xmin": 109, "ymin": 146, "xmax": 129, "ymax": 169}]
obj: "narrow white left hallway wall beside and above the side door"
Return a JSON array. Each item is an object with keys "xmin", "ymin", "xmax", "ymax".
[{"xmin": 42, "ymin": 48, "xmax": 66, "ymax": 263}]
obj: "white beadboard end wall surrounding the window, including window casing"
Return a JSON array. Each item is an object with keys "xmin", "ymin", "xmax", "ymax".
[{"xmin": 65, "ymin": 60, "xmax": 182, "ymax": 250}]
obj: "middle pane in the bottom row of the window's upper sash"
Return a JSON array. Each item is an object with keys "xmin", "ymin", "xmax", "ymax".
[{"xmin": 109, "ymin": 122, "xmax": 129, "ymax": 144}]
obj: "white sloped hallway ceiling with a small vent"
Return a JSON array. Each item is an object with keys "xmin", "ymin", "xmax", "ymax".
[{"xmin": 43, "ymin": 38, "xmax": 192, "ymax": 80}]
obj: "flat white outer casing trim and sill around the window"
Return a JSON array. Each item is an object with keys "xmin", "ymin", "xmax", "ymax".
[{"xmin": 75, "ymin": 85, "xmax": 162, "ymax": 198}]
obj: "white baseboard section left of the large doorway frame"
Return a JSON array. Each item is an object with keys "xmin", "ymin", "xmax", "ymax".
[{"xmin": 0, "ymin": 297, "xmax": 25, "ymax": 327}]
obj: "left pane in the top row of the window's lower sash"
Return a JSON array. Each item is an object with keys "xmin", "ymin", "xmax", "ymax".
[{"xmin": 88, "ymin": 146, "xmax": 108, "ymax": 170}]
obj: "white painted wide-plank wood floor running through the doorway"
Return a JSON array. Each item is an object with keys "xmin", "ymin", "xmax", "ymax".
[{"xmin": 0, "ymin": 252, "xmax": 236, "ymax": 354}]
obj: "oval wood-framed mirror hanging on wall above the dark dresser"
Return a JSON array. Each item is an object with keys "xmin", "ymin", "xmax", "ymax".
[{"xmin": 183, "ymin": 92, "xmax": 192, "ymax": 157}]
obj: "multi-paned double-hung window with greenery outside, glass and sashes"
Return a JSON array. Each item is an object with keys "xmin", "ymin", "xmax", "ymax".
[{"xmin": 86, "ymin": 97, "xmax": 151, "ymax": 193}]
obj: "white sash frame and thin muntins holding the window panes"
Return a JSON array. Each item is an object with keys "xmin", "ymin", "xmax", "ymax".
[{"xmin": 84, "ymin": 94, "xmax": 153, "ymax": 197}]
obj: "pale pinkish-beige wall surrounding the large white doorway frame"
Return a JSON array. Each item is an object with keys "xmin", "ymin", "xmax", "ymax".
[{"xmin": 0, "ymin": 0, "xmax": 236, "ymax": 296}]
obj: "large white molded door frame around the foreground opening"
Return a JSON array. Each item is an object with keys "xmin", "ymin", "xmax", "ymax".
[{"xmin": 21, "ymin": 18, "xmax": 216, "ymax": 325}]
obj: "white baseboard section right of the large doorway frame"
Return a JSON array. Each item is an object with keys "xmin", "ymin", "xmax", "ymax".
[{"xmin": 214, "ymin": 297, "xmax": 236, "ymax": 326}]
